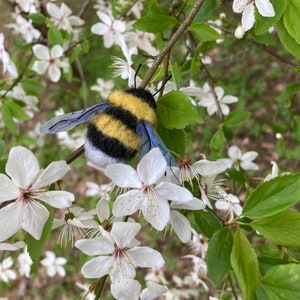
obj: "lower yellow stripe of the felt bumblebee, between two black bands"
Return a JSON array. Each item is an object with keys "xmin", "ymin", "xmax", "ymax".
[{"xmin": 91, "ymin": 113, "xmax": 139, "ymax": 150}]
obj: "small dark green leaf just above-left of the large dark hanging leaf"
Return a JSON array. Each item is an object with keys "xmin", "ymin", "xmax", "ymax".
[{"xmin": 193, "ymin": 210, "xmax": 221, "ymax": 238}]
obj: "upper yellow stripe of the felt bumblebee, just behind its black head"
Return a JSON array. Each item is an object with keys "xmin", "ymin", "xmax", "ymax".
[{"xmin": 109, "ymin": 91, "xmax": 156, "ymax": 126}]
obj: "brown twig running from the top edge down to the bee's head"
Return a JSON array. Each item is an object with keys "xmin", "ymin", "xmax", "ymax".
[{"xmin": 140, "ymin": 0, "xmax": 204, "ymax": 88}]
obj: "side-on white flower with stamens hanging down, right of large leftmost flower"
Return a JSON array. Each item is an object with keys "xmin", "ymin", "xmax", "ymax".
[{"xmin": 52, "ymin": 206, "xmax": 98, "ymax": 246}]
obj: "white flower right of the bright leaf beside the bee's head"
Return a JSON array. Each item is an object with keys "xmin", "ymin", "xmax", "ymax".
[{"xmin": 198, "ymin": 86, "xmax": 238, "ymax": 116}]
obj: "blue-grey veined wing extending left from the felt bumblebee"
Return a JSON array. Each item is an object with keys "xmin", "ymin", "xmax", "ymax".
[{"xmin": 41, "ymin": 102, "xmax": 110, "ymax": 134}]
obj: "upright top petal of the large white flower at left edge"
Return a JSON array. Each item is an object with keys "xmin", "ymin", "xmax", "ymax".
[{"xmin": 5, "ymin": 146, "xmax": 40, "ymax": 188}]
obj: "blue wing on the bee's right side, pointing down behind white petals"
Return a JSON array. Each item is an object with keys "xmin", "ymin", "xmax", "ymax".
[{"xmin": 136, "ymin": 122, "xmax": 178, "ymax": 167}]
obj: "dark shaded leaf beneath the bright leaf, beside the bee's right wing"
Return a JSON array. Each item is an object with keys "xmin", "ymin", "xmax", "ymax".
[{"xmin": 156, "ymin": 126, "xmax": 185, "ymax": 156}]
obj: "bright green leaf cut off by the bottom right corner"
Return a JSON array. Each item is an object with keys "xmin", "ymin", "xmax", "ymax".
[{"xmin": 262, "ymin": 264, "xmax": 300, "ymax": 300}]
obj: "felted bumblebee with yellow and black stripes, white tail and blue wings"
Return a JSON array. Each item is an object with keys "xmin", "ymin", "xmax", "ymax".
[{"xmin": 41, "ymin": 88, "xmax": 174, "ymax": 167}]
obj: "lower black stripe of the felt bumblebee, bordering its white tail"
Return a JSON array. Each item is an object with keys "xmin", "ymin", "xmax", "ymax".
[{"xmin": 86, "ymin": 123, "xmax": 137, "ymax": 161}]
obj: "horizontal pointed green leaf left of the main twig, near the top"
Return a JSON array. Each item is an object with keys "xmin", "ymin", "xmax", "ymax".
[{"xmin": 133, "ymin": 14, "xmax": 180, "ymax": 33}]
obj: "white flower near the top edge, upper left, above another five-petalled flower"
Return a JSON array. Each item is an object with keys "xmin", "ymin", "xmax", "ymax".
[{"xmin": 46, "ymin": 2, "xmax": 84, "ymax": 34}]
